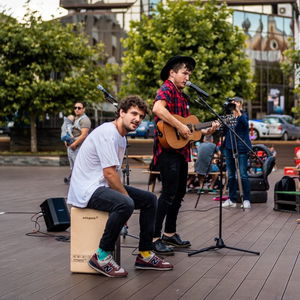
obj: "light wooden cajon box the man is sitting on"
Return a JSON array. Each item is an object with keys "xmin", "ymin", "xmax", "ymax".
[{"xmin": 70, "ymin": 207, "xmax": 120, "ymax": 273}]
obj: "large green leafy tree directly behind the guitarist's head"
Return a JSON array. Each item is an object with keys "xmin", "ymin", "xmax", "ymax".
[{"xmin": 122, "ymin": 0, "xmax": 255, "ymax": 118}]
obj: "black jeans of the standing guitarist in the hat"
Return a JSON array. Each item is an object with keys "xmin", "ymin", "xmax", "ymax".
[{"xmin": 154, "ymin": 151, "xmax": 188, "ymax": 238}]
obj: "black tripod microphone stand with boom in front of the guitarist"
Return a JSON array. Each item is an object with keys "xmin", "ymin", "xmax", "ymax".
[{"xmin": 188, "ymin": 92, "xmax": 260, "ymax": 256}]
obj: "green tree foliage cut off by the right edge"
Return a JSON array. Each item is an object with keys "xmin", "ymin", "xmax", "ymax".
[{"xmin": 281, "ymin": 41, "xmax": 300, "ymax": 124}]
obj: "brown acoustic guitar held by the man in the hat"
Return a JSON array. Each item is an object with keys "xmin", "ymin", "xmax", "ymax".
[{"xmin": 157, "ymin": 115, "xmax": 212, "ymax": 149}]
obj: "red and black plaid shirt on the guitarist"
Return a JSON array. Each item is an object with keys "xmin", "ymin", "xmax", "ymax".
[{"xmin": 153, "ymin": 80, "xmax": 191, "ymax": 164}]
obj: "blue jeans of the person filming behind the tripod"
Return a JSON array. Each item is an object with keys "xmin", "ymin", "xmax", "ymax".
[{"xmin": 224, "ymin": 148, "xmax": 251, "ymax": 202}]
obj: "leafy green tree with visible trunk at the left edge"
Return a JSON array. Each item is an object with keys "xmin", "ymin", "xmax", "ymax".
[{"xmin": 0, "ymin": 13, "xmax": 116, "ymax": 152}]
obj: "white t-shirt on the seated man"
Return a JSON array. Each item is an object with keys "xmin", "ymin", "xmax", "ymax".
[{"xmin": 67, "ymin": 122, "xmax": 126, "ymax": 207}]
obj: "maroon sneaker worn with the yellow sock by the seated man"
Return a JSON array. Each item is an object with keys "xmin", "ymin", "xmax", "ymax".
[{"xmin": 135, "ymin": 253, "xmax": 173, "ymax": 271}]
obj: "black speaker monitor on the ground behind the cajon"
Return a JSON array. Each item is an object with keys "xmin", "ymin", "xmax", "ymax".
[{"xmin": 40, "ymin": 198, "xmax": 70, "ymax": 231}]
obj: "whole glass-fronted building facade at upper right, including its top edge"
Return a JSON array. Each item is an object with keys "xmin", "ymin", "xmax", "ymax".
[{"xmin": 228, "ymin": 1, "xmax": 299, "ymax": 118}]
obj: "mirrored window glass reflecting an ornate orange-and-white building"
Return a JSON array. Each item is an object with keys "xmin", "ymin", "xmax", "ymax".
[{"xmin": 233, "ymin": 11, "xmax": 293, "ymax": 117}]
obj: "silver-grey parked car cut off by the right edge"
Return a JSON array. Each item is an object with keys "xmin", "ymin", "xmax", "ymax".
[{"xmin": 262, "ymin": 115, "xmax": 300, "ymax": 141}]
